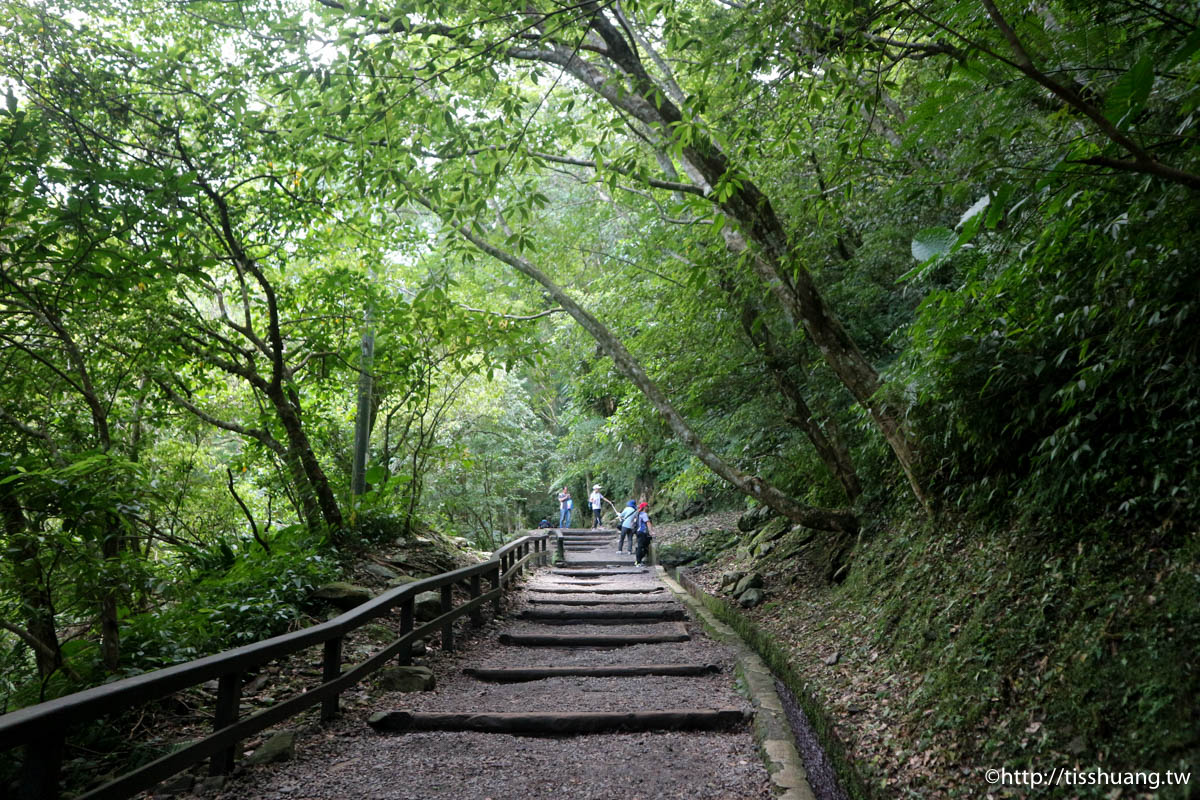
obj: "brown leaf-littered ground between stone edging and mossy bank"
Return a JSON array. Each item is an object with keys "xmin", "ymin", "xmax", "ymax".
[{"xmin": 655, "ymin": 512, "xmax": 969, "ymax": 800}]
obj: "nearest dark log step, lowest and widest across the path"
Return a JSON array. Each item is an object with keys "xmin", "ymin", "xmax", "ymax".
[{"xmin": 367, "ymin": 709, "xmax": 749, "ymax": 735}]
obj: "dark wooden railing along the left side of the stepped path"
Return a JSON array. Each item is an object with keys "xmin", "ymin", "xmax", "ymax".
[{"xmin": 0, "ymin": 534, "xmax": 550, "ymax": 800}]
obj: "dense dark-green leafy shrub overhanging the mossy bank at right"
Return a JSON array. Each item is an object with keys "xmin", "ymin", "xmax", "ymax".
[{"xmin": 901, "ymin": 182, "xmax": 1200, "ymax": 525}]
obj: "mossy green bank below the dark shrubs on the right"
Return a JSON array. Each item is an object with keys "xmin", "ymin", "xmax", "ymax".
[{"xmin": 839, "ymin": 513, "xmax": 1200, "ymax": 796}]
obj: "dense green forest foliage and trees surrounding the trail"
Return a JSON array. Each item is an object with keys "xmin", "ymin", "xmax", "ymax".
[{"xmin": 0, "ymin": 0, "xmax": 1200, "ymax": 796}]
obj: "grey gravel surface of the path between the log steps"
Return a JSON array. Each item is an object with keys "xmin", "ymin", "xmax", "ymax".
[{"xmin": 218, "ymin": 537, "xmax": 773, "ymax": 800}]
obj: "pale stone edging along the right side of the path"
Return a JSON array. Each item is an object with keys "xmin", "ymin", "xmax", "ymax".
[{"xmin": 655, "ymin": 566, "xmax": 815, "ymax": 800}]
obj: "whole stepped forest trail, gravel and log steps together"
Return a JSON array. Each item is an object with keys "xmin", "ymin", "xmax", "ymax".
[{"xmin": 214, "ymin": 530, "xmax": 787, "ymax": 800}]
